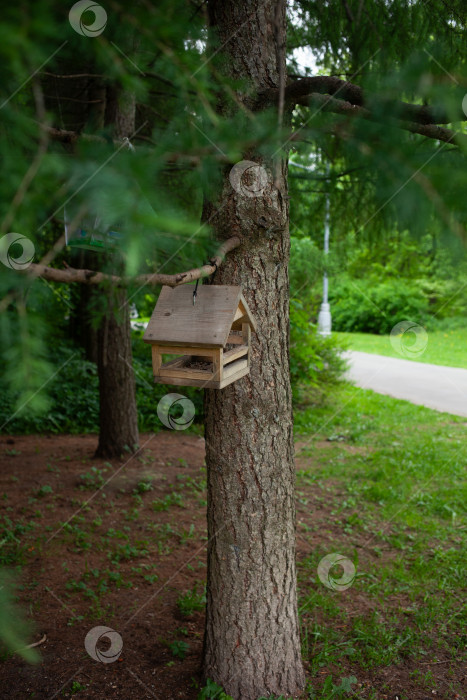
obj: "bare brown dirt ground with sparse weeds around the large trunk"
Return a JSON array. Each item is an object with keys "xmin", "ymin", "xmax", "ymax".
[{"xmin": 0, "ymin": 431, "xmax": 467, "ymax": 700}]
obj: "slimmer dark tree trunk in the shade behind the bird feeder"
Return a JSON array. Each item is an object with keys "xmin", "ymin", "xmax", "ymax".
[{"xmin": 96, "ymin": 93, "xmax": 139, "ymax": 458}]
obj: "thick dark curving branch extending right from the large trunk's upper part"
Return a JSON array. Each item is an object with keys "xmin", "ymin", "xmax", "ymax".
[{"xmin": 260, "ymin": 75, "xmax": 466, "ymax": 124}]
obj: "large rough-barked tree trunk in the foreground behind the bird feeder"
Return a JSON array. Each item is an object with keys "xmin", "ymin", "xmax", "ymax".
[{"xmin": 203, "ymin": 0, "xmax": 304, "ymax": 700}]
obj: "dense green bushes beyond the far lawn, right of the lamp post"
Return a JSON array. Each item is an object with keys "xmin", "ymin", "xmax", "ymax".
[{"xmin": 322, "ymin": 231, "xmax": 467, "ymax": 334}]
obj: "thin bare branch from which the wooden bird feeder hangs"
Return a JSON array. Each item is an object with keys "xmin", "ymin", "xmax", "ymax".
[{"xmin": 26, "ymin": 236, "xmax": 241, "ymax": 287}]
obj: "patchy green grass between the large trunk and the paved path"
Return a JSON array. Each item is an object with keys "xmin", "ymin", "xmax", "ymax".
[{"xmin": 295, "ymin": 384, "xmax": 467, "ymax": 700}]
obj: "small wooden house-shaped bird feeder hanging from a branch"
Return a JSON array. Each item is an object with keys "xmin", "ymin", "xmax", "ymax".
[{"xmin": 143, "ymin": 284, "xmax": 256, "ymax": 389}]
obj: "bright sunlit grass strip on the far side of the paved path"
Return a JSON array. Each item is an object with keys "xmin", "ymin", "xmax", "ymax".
[{"xmin": 336, "ymin": 324, "xmax": 467, "ymax": 369}]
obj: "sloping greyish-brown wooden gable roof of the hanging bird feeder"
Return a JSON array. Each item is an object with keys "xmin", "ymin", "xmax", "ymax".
[{"xmin": 143, "ymin": 284, "xmax": 256, "ymax": 347}]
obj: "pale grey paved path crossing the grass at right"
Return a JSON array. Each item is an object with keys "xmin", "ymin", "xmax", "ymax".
[{"xmin": 345, "ymin": 350, "xmax": 467, "ymax": 417}]
